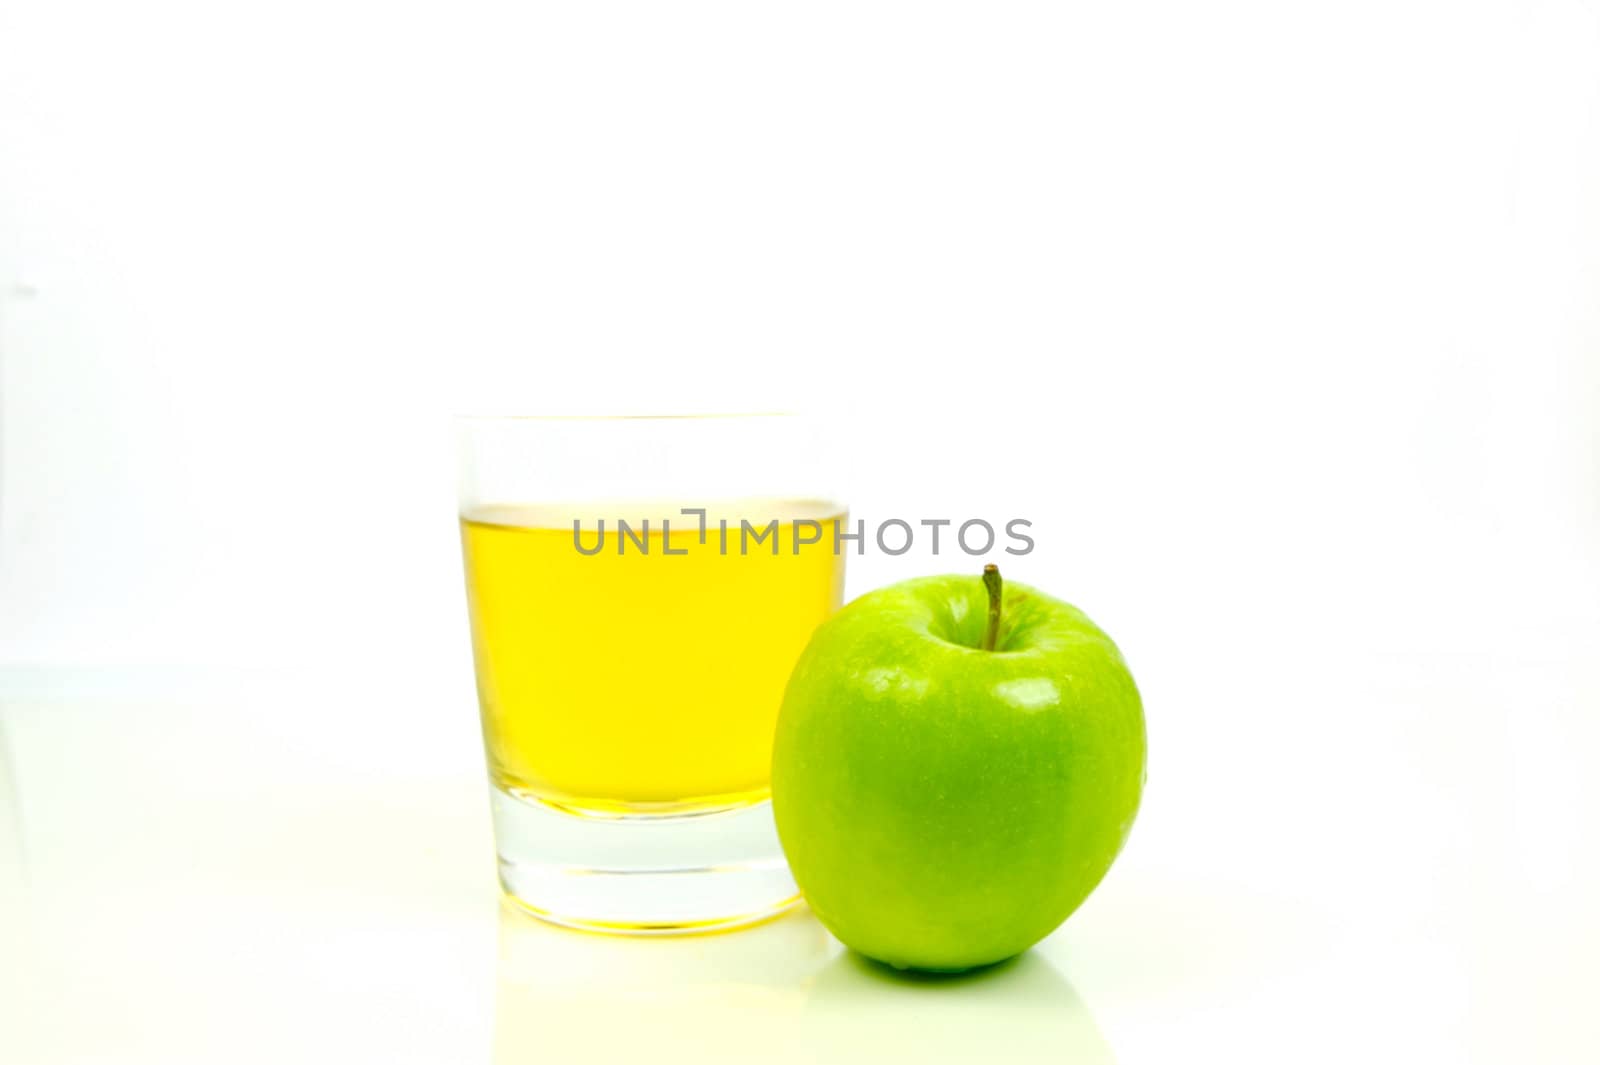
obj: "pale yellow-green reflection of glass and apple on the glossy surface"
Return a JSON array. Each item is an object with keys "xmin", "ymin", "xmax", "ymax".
[{"xmin": 493, "ymin": 903, "xmax": 1115, "ymax": 1065}]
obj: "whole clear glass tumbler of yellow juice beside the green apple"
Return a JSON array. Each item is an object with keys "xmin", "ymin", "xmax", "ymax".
[{"xmin": 458, "ymin": 414, "xmax": 850, "ymax": 934}]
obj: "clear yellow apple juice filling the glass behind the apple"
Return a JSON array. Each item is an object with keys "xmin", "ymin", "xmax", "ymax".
[{"xmin": 461, "ymin": 501, "xmax": 850, "ymax": 811}]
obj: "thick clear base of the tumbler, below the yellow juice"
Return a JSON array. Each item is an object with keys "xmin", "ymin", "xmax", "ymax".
[{"xmin": 490, "ymin": 787, "xmax": 800, "ymax": 935}]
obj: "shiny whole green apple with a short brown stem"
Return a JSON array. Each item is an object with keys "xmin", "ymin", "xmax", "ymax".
[{"xmin": 773, "ymin": 566, "xmax": 1144, "ymax": 971}]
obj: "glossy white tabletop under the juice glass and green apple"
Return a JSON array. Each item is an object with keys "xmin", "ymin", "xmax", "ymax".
[{"xmin": 0, "ymin": 644, "xmax": 1600, "ymax": 1065}]
